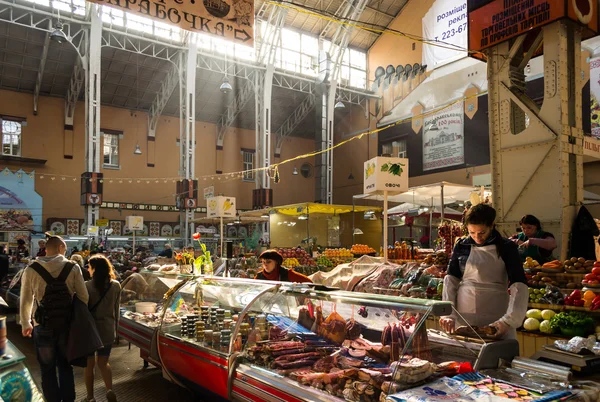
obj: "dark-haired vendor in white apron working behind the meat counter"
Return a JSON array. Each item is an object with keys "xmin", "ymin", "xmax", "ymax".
[{"xmin": 440, "ymin": 204, "xmax": 529, "ymax": 339}]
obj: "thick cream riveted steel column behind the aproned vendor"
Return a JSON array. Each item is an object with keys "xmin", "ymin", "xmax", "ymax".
[{"xmin": 487, "ymin": 21, "xmax": 583, "ymax": 259}]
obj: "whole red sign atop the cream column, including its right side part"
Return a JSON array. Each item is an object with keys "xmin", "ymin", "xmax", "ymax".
[{"xmin": 468, "ymin": 0, "xmax": 598, "ymax": 51}]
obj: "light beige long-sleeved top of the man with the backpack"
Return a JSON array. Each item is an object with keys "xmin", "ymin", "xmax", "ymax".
[{"xmin": 20, "ymin": 254, "xmax": 89, "ymax": 329}]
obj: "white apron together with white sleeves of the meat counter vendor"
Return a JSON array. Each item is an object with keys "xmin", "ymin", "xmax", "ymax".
[{"xmin": 442, "ymin": 245, "xmax": 529, "ymax": 339}]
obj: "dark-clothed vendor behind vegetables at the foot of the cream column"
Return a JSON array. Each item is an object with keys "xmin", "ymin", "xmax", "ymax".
[{"xmin": 510, "ymin": 215, "xmax": 556, "ymax": 264}]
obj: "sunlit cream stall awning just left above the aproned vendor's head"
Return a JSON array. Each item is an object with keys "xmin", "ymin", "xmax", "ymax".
[{"xmin": 354, "ymin": 182, "xmax": 479, "ymax": 207}]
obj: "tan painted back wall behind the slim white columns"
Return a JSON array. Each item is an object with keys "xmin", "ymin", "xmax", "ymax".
[{"xmin": 0, "ymin": 90, "xmax": 314, "ymax": 229}]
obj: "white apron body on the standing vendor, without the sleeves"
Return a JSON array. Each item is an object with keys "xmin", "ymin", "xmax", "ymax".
[{"xmin": 456, "ymin": 244, "xmax": 516, "ymax": 339}]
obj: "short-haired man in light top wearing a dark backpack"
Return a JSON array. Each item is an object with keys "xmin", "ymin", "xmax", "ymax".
[{"xmin": 20, "ymin": 236, "xmax": 89, "ymax": 402}]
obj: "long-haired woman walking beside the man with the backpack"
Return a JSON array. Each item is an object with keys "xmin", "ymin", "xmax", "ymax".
[{"xmin": 83, "ymin": 254, "xmax": 121, "ymax": 402}]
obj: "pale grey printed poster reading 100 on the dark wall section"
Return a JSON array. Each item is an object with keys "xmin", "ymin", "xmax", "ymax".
[{"xmin": 423, "ymin": 102, "xmax": 465, "ymax": 170}]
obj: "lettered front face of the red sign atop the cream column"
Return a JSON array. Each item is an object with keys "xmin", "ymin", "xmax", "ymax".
[{"xmin": 469, "ymin": 0, "xmax": 565, "ymax": 50}]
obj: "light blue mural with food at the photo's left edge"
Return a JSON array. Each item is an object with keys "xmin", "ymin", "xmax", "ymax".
[{"xmin": 0, "ymin": 169, "xmax": 42, "ymax": 232}]
